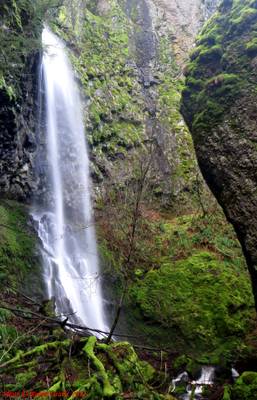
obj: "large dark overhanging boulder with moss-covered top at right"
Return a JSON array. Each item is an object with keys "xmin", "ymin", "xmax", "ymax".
[{"xmin": 182, "ymin": 0, "xmax": 257, "ymax": 310}]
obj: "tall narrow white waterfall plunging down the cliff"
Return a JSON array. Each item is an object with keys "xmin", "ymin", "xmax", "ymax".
[{"xmin": 33, "ymin": 27, "xmax": 107, "ymax": 330}]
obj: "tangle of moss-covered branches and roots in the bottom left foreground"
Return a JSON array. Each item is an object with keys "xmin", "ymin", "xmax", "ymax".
[{"xmin": 0, "ymin": 337, "xmax": 174, "ymax": 400}]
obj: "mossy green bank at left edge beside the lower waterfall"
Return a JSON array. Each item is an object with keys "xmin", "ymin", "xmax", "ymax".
[{"xmin": 0, "ymin": 200, "xmax": 41, "ymax": 368}]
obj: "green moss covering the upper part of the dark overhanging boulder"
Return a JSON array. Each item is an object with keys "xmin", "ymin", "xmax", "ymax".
[{"xmin": 182, "ymin": 0, "xmax": 257, "ymax": 134}]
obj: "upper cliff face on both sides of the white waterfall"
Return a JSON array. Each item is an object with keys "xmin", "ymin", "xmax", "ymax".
[{"xmin": 0, "ymin": 0, "xmax": 216, "ymax": 202}]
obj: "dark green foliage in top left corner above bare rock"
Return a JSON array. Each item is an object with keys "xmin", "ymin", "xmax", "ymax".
[{"xmin": 0, "ymin": 0, "xmax": 58, "ymax": 101}]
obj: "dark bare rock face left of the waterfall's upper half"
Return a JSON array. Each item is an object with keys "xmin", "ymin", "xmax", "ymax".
[{"xmin": 0, "ymin": 58, "xmax": 38, "ymax": 200}]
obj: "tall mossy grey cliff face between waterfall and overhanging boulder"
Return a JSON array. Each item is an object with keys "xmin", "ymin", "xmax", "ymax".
[{"xmin": 55, "ymin": 0, "xmax": 216, "ymax": 203}]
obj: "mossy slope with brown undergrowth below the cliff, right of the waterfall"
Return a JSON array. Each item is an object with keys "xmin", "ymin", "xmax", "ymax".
[{"xmin": 97, "ymin": 197, "xmax": 255, "ymax": 366}]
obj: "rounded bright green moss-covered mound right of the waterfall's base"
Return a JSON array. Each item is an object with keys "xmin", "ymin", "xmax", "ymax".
[{"xmin": 129, "ymin": 252, "xmax": 251, "ymax": 362}]
